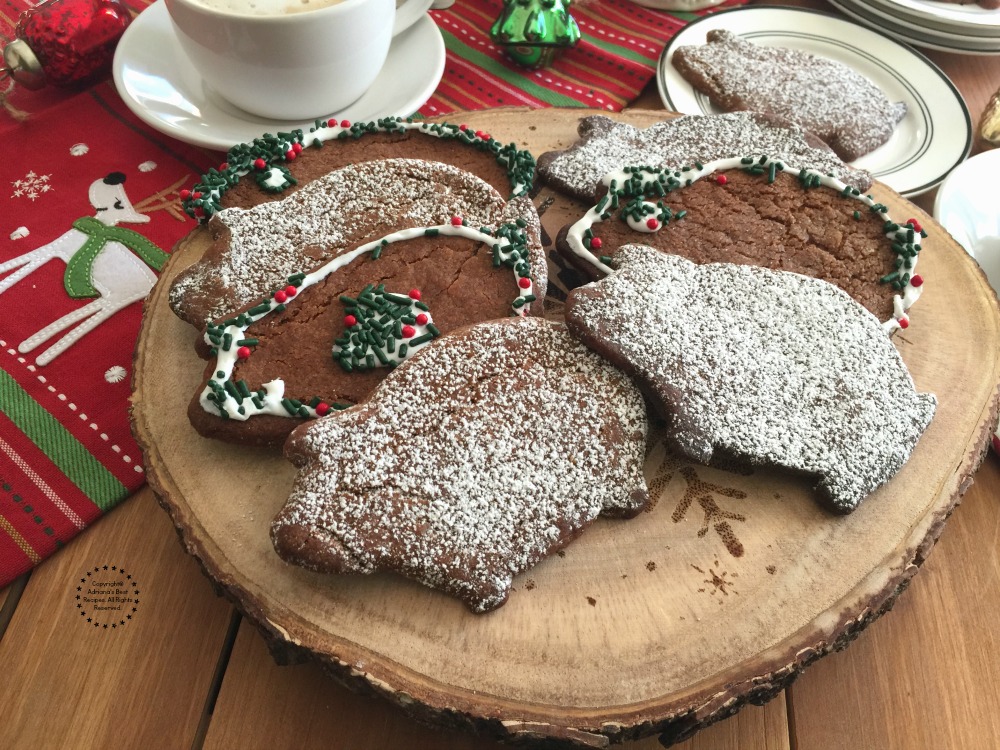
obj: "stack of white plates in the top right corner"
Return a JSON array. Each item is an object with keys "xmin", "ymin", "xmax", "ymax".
[{"xmin": 830, "ymin": 0, "xmax": 1000, "ymax": 55}]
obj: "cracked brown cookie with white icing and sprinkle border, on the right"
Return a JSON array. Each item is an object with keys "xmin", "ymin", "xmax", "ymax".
[{"xmin": 556, "ymin": 157, "xmax": 923, "ymax": 329}]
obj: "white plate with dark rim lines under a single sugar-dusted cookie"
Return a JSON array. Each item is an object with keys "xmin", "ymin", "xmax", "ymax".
[{"xmin": 657, "ymin": 6, "xmax": 972, "ymax": 196}]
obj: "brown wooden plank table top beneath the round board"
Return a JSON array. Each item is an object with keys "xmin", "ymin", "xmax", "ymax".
[{"xmin": 0, "ymin": 0, "xmax": 1000, "ymax": 750}]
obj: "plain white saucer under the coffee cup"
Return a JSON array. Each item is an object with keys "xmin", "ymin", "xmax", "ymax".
[{"xmin": 114, "ymin": 0, "xmax": 445, "ymax": 151}]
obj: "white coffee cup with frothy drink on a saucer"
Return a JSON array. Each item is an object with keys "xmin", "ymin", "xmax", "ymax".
[{"xmin": 166, "ymin": 0, "xmax": 432, "ymax": 121}]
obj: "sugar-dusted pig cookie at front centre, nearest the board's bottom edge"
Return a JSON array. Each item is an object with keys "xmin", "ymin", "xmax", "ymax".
[{"xmin": 271, "ymin": 318, "xmax": 648, "ymax": 612}]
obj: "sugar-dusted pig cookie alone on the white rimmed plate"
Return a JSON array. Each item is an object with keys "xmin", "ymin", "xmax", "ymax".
[{"xmin": 671, "ymin": 29, "xmax": 906, "ymax": 166}]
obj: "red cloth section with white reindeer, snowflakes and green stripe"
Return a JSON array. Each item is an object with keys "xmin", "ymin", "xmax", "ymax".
[{"xmin": 0, "ymin": 84, "xmax": 219, "ymax": 588}]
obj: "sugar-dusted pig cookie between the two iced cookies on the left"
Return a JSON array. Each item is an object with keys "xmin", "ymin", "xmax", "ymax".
[{"xmin": 170, "ymin": 159, "xmax": 506, "ymax": 318}]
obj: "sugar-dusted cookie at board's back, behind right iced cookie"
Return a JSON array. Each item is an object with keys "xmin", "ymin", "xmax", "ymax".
[{"xmin": 538, "ymin": 112, "xmax": 872, "ymax": 201}]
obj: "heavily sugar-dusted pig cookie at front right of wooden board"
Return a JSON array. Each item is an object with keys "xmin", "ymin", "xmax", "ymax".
[{"xmin": 566, "ymin": 250, "xmax": 936, "ymax": 513}]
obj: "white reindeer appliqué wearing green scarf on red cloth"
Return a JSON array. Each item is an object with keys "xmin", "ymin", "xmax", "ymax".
[{"xmin": 0, "ymin": 172, "xmax": 170, "ymax": 365}]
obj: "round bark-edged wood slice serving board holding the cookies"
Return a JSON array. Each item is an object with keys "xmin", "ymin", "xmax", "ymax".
[{"xmin": 132, "ymin": 110, "xmax": 1000, "ymax": 747}]
